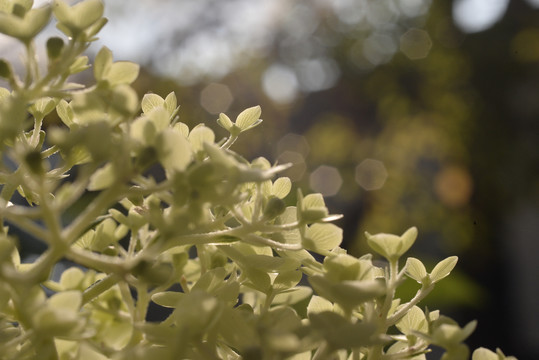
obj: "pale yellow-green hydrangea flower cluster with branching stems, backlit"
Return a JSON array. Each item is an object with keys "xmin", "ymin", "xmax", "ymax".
[{"xmin": 0, "ymin": 0, "xmax": 510, "ymax": 360}]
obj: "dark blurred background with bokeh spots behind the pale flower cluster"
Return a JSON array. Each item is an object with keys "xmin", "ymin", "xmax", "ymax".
[{"xmin": 0, "ymin": 0, "xmax": 539, "ymax": 360}]
